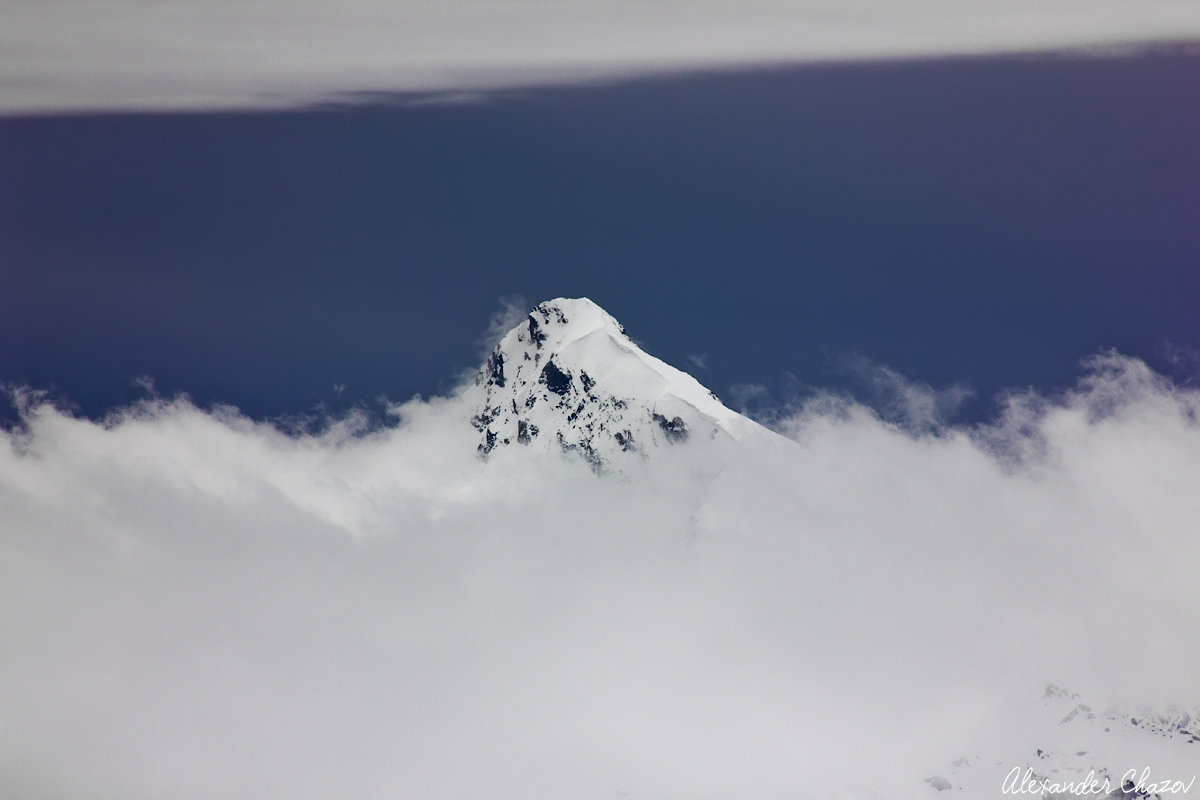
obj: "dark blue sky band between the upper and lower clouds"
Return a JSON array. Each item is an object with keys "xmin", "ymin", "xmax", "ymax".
[{"xmin": 0, "ymin": 53, "xmax": 1200, "ymax": 416}]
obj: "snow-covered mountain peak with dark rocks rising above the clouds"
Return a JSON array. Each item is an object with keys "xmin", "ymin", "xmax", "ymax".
[{"xmin": 472, "ymin": 297, "xmax": 754, "ymax": 471}]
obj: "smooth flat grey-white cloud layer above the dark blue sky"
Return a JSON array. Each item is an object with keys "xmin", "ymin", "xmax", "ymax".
[{"xmin": 7, "ymin": 0, "xmax": 1200, "ymax": 114}]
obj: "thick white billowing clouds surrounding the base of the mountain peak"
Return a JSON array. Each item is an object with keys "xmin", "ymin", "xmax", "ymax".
[{"xmin": 7, "ymin": 355, "xmax": 1200, "ymax": 800}]
